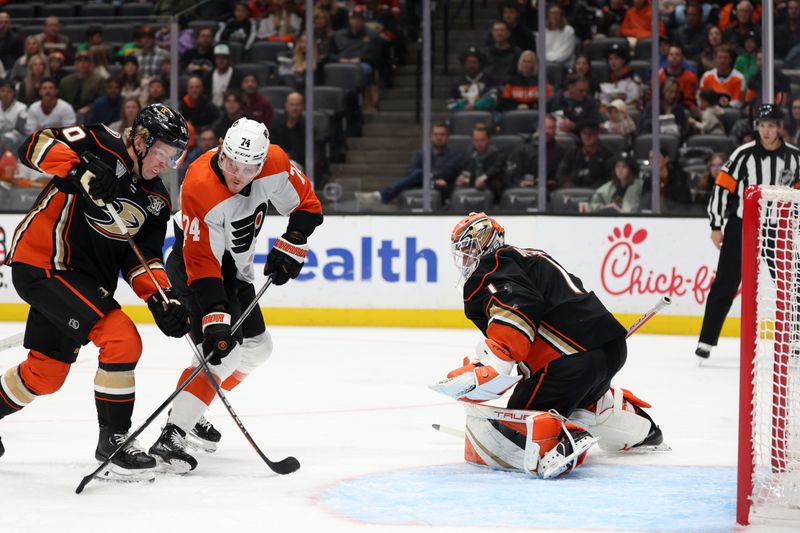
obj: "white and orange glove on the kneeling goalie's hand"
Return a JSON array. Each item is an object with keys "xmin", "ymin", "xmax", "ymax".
[{"xmin": 429, "ymin": 340, "xmax": 522, "ymax": 402}]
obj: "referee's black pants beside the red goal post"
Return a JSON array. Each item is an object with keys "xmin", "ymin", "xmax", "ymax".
[{"xmin": 700, "ymin": 216, "xmax": 742, "ymax": 346}]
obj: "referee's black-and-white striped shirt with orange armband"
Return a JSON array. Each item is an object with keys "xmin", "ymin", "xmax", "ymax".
[{"xmin": 708, "ymin": 141, "xmax": 800, "ymax": 229}]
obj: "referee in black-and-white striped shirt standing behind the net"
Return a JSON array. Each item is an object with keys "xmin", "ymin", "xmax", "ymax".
[{"xmin": 694, "ymin": 104, "xmax": 800, "ymax": 359}]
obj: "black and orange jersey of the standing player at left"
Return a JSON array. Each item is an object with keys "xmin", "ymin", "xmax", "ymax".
[{"xmin": 6, "ymin": 124, "xmax": 172, "ymax": 298}]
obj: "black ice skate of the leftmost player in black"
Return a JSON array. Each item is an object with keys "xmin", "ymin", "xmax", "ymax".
[{"xmin": 94, "ymin": 427, "xmax": 156, "ymax": 482}]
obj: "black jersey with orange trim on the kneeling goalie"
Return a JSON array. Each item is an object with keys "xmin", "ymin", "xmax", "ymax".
[{"xmin": 464, "ymin": 246, "xmax": 626, "ymax": 372}]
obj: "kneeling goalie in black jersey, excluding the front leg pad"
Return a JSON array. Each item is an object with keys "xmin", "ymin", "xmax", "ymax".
[{"xmin": 431, "ymin": 213, "xmax": 663, "ymax": 478}]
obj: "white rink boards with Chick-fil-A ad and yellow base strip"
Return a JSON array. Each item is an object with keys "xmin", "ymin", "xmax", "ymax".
[{"xmin": 0, "ymin": 211, "xmax": 739, "ymax": 335}]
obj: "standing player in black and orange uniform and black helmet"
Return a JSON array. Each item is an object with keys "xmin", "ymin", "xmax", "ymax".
[{"xmin": 0, "ymin": 104, "xmax": 189, "ymax": 480}]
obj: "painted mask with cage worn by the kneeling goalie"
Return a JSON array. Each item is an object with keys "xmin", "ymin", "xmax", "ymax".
[{"xmin": 450, "ymin": 212, "xmax": 506, "ymax": 281}]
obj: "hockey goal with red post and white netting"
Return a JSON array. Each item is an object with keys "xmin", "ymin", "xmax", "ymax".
[{"xmin": 736, "ymin": 186, "xmax": 800, "ymax": 524}]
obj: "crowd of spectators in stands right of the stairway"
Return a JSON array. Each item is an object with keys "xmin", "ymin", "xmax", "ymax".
[{"xmin": 359, "ymin": 0, "xmax": 800, "ymax": 214}]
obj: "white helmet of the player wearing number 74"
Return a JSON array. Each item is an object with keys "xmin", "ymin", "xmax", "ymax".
[{"xmin": 220, "ymin": 118, "xmax": 269, "ymax": 179}]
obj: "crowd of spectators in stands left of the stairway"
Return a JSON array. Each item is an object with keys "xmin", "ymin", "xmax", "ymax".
[{"xmin": 0, "ymin": 0, "xmax": 404, "ymax": 197}]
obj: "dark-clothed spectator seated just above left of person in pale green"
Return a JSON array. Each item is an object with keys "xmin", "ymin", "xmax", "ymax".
[{"xmin": 556, "ymin": 120, "xmax": 614, "ymax": 189}]
